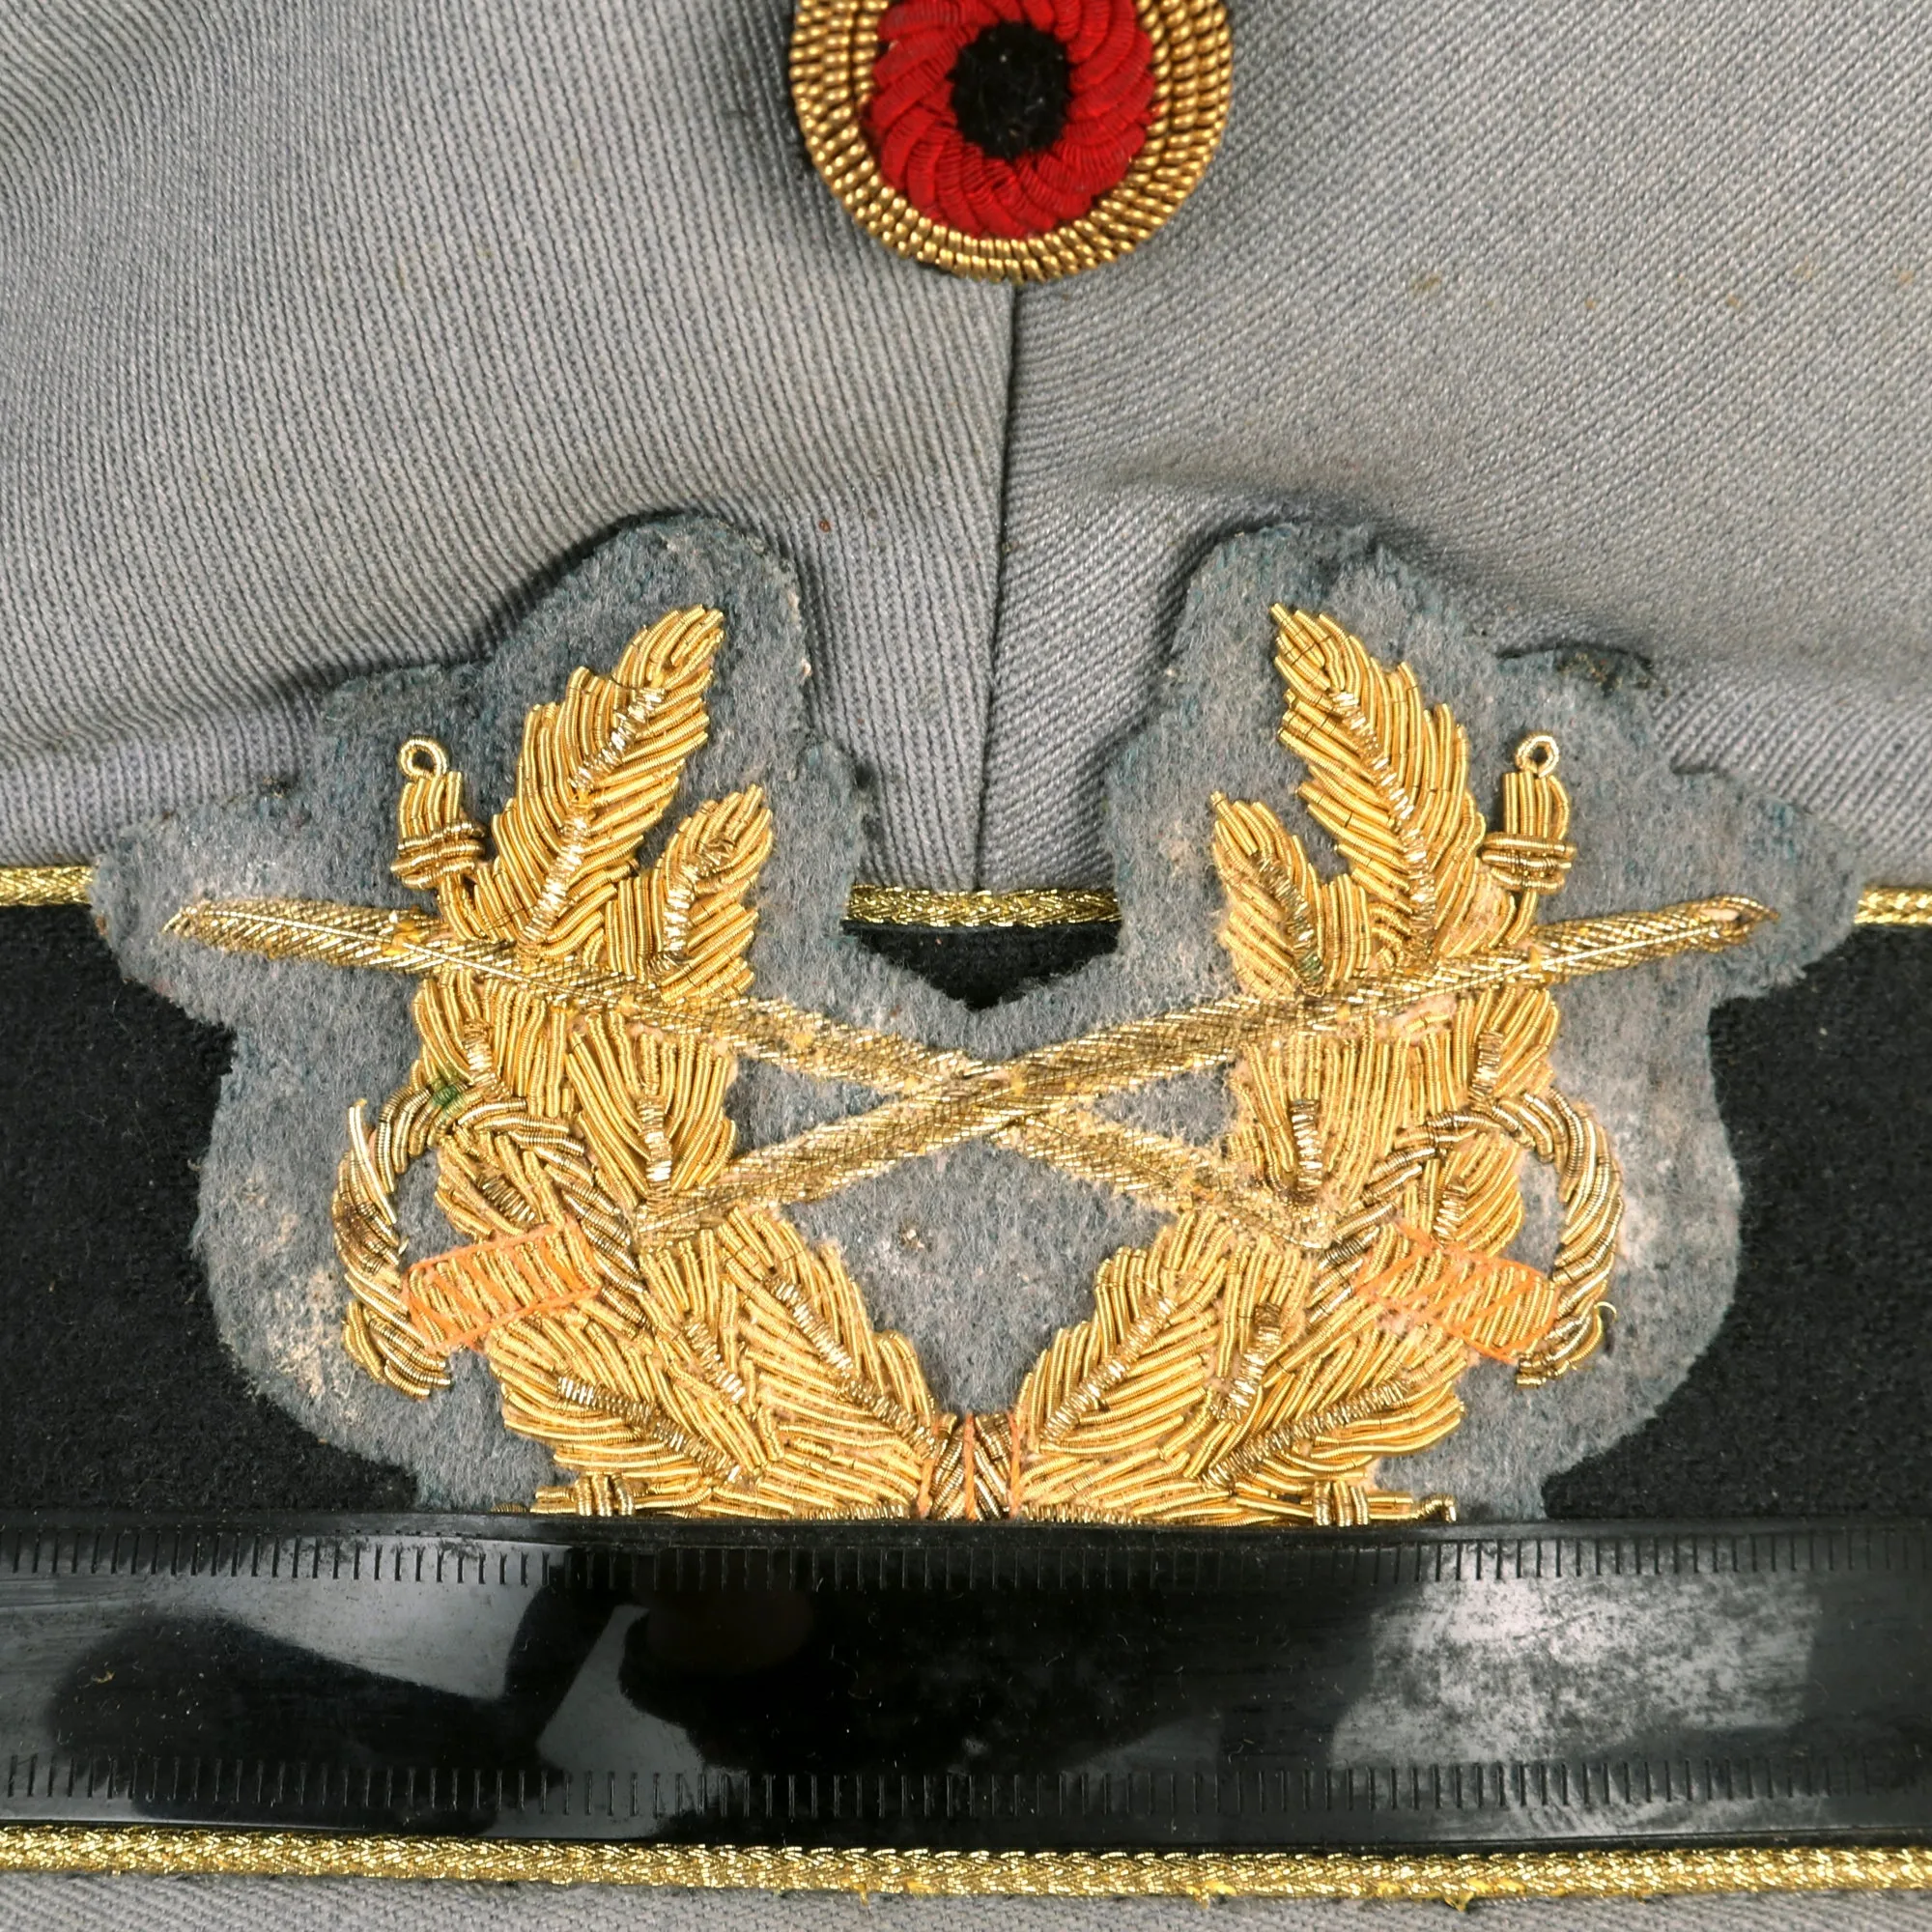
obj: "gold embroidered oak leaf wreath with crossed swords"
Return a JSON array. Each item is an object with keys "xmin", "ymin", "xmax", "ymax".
[{"xmin": 170, "ymin": 607, "xmax": 1768, "ymax": 1522}]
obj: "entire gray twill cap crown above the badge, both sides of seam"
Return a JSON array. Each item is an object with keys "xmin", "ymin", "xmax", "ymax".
[{"xmin": 0, "ymin": 0, "xmax": 1932, "ymax": 887}]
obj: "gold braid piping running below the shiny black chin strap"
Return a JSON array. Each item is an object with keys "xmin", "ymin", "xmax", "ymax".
[{"xmin": 0, "ymin": 1826, "xmax": 1932, "ymax": 1905}]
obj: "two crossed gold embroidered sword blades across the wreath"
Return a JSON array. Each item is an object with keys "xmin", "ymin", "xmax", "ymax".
[{"xmin": 168, "ymin": 896, "xmax": 1770, "ymax": 1246}]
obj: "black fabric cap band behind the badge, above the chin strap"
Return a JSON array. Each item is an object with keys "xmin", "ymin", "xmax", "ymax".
[{"xmin": 0, "ymin": 908, "xmax": 1932, "ymax": 1519}]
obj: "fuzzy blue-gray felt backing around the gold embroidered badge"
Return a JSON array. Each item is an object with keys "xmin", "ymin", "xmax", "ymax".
[{"xmin": 95, "ymin": 520, "xmax": 1862, "ymax": 1517}]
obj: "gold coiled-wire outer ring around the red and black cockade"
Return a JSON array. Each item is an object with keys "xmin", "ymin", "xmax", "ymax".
[{"xmin": 792, "ymin": 0, "xmax": 1233, "ymax": 282}]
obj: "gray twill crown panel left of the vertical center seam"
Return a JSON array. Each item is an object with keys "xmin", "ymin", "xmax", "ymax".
[{"xmin": 0, "ymin": 0, "xmax": 1010, "ymax": 887}]
